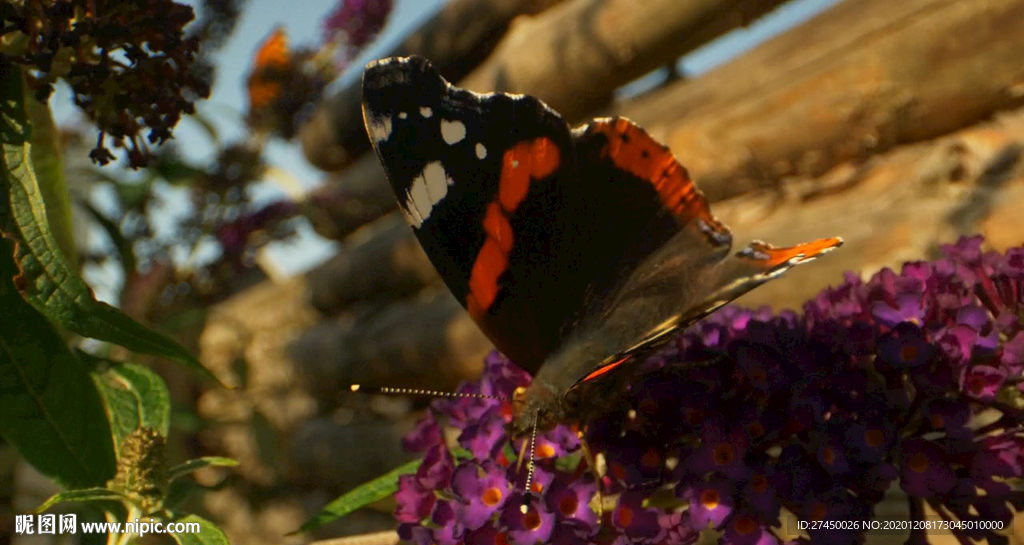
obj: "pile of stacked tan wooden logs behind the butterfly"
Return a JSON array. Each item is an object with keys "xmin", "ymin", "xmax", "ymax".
[{"xmin": 195, "ymin": 0, "xmax": 1024, "ymax": 543}]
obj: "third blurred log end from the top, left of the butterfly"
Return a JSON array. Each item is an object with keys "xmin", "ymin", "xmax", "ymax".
[{"xmin": 306, "ymin": 213, "xmax": 439, "ymax": 315}]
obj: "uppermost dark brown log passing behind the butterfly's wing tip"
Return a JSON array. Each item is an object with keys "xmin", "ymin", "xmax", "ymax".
[{"xmin": 299, "ymin": 0, "xmax": 560, "ymax": 171}]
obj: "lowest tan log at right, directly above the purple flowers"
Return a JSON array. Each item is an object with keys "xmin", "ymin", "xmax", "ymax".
[{"xmin": 715, "ymin": 109, "xmax": 1024, "ymax": 309}]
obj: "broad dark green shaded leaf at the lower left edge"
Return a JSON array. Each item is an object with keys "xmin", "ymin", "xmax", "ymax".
[{"xmin": 0, "ymin": 238, "xmax": 115, "ymax": 488}]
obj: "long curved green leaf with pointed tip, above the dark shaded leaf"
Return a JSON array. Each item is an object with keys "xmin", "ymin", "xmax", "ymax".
[{"xmin": 0, "ymin": 63, "xmax": 224, "ymax": 385}]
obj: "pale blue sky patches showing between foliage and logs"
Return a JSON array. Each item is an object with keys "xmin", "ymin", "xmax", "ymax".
[{"xmin": 58, "ymin": 0, "xmax": 839, "ymax": 297}]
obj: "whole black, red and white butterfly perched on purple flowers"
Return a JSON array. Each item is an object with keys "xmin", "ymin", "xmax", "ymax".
[{"xmin": 362, "ymin": 56, "xmax": 843, "ymax": 442}]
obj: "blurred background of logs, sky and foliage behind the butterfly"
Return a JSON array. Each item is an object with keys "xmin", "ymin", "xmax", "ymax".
[{"xmin": 8, "ymin": 0, "xmax": 1024, "ymax": 545}]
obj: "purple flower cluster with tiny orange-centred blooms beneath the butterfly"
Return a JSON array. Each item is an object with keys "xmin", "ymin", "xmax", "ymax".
[{"xmin": 396, "ymin": 237, "xmax": 1024, "ymax": 545}]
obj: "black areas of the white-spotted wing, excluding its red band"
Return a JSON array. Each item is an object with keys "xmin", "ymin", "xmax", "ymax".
[{"xmin": 362, "ymin": 57, "xmax": 574, "ymax": 371}]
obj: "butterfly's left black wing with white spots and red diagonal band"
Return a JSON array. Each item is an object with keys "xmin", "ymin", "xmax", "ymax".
[{"xmin": 362, "ymin": 57, "xmax": 577, "ymax": 371}]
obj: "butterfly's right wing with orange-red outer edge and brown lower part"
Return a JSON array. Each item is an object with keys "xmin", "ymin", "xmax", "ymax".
[{"xmin": 537, "ymin": 118, "xmax": 842, "ymax": 391}]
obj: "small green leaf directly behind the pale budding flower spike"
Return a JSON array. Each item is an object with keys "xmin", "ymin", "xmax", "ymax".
[{"xmin": 88, "ymin": 352, "xmax": 171, "ymax": 449}]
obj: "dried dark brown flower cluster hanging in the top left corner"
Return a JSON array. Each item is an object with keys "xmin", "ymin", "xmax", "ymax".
[{"xmin": 0, "ymin": 0, "xmax": 210, "ymax": 168}]
